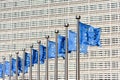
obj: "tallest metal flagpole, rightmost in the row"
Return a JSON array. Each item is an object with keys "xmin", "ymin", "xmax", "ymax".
[{"xmin": 76, "ymin": 16, "xmax": 81, "ymax": 80}]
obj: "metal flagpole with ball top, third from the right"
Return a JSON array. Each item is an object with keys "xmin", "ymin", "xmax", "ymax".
[{"xmin": 54, "ymin": 30, "xmax": 59, "ymax": 80}]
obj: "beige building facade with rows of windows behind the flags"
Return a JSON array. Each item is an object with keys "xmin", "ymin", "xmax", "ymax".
[{"xmin": 0, "ymin": 0, "xmax": 120, "ymax": 80}]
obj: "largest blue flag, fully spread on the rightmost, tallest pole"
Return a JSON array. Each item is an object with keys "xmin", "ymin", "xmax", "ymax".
[{"xmin": 80, "ymin": 22, "xmax": 101, "ymax": 46}]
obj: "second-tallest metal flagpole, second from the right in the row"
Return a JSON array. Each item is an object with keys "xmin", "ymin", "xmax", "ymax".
[{"xmin": 64, "ymin": 24, "xmax": 69, "ymax": 80}]
